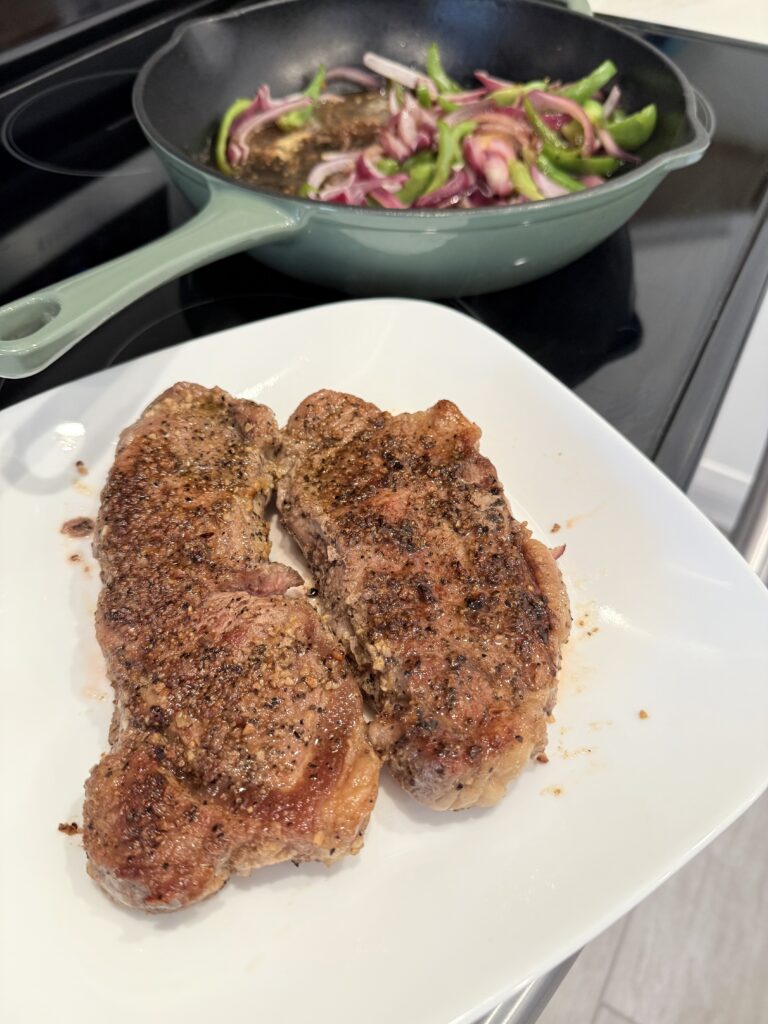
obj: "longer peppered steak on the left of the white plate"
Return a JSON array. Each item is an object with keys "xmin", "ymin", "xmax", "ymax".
[{"xmin": 84, "ymin": 384, "xmax": 378, "ymax": 910}]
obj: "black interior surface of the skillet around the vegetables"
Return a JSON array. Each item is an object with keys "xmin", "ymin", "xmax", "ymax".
[{"xmin": 135, "ymin": 0, "xmax": 693, "ymax": 202}]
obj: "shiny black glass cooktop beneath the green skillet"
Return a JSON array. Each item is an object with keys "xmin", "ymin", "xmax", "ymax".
[{"xmin": 0, "ymin": 2, "xmax": 768, "ymax": 484}]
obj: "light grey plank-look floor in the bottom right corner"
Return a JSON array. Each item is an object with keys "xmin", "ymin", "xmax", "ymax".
[{"xmin": 539, "ymin": 794, "xmax": 768, "ymax": 1024}]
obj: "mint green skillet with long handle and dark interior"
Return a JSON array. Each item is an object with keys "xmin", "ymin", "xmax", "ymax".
[{"xmin": 0, "ymin": 0, "xmax": 714, "ymax": 377}]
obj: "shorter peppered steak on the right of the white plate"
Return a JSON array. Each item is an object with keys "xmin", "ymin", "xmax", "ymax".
[{"xmin": 278, "ymin": 391, "xmax": 570, "ymax": 810}]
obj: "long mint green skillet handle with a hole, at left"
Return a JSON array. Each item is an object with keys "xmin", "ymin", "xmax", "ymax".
[{"xmin": 0, "ymin": 185, "xmax": 302, "ymax": 377}]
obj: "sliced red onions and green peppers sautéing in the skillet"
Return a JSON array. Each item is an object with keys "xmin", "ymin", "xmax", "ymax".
[{"xmin": 214, "ymin": 43, "xmax": 656, "ymax": 210}]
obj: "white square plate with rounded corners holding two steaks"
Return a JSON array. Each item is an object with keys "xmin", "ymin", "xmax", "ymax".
[{"xmin": 0, "ymin": 300, "xmax": 768, "ymax": 1024}]
